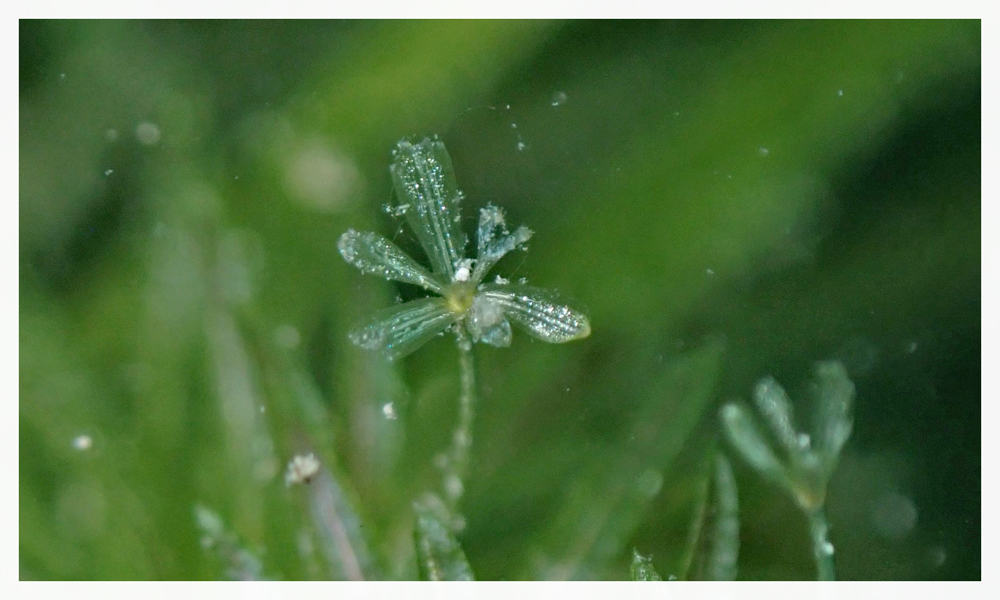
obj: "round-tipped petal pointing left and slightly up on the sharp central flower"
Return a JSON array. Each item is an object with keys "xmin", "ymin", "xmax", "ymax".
[{"xmin": 337, "ymin": 229, "xmax": 442, "ymax": 293}]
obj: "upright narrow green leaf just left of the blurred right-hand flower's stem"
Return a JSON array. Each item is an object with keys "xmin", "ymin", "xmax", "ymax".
[{"xmin": 707, "ymin": 453, "xmax": 740, "ymax": 581}]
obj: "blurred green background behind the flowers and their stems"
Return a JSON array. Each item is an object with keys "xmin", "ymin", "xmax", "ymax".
[{"xmin": 19, "ymin": 21, "xmax": 981, "ymax": 585}]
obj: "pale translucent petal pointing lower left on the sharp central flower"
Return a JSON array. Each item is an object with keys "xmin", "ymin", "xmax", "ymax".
[{"xmin": 348, "ymin": 297, "xmax": 457, "ymax": 360}]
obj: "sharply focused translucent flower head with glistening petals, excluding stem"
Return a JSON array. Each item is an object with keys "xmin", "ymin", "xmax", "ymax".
[{"xmin": 337, "ymin": 139, "xmax": 590, "ymax": 360}]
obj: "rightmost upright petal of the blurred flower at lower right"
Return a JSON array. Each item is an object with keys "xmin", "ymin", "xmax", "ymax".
[{"xmin": 812, "ymin": 361, "xmax": 854, "ymax": 472}]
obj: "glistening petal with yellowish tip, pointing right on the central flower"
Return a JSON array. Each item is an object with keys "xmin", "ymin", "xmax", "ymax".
[{"xmin": 480, "ymin": 283, "xmax": 590, "ymax": 344}]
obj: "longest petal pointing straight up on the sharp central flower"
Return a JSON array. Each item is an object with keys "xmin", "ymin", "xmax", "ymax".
[{"xmin": 389, "ymin": 138, "xmax": 466, "ymax": 281}]
